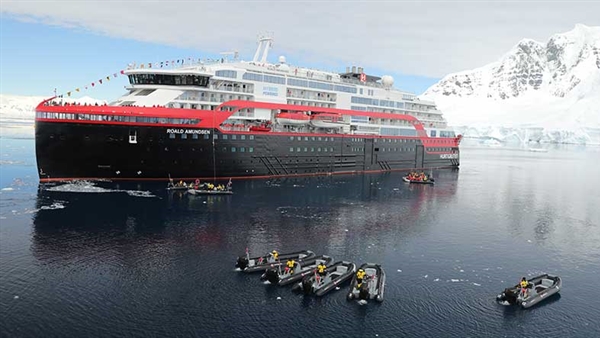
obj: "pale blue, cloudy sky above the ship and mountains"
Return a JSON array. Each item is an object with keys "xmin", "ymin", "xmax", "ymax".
[{"xmin": 0, "ymin": 0, "xmax": 600, "ymax": 101}]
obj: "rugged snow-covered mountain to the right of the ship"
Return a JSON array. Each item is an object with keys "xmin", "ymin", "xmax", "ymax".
[{"xmin": 421, "ymin": 24, "xmax": 600, "ymax": 144}]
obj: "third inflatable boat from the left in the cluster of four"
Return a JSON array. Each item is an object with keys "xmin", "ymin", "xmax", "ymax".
[{"xmin": 292, "ymin": 261, "xmax": 356, "ymax": 297}]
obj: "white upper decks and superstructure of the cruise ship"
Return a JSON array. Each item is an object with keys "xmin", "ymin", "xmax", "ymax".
[{"xmin": 113, "ymin": 36, "xmax": 454, "ymax": 137}]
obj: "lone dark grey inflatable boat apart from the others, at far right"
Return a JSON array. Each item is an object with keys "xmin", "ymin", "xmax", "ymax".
[{"xmin": 496, "ymin": 274, "xmax": 562, "ymax": 309}]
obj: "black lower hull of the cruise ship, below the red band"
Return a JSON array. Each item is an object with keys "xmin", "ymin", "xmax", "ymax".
[{"xmin": 35, "ymin": 120, "xmax": 459, "ymax": 182}]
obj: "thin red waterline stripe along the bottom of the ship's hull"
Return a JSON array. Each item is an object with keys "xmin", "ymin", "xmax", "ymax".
[{"xmin": 40, "ymin": 166, "xmax": 454, "ymax": 183}]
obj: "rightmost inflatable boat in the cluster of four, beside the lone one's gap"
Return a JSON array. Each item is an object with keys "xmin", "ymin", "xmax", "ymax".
[{"xmin": 346, "ymin": 263, "xmax": 385, "ymax": 302}]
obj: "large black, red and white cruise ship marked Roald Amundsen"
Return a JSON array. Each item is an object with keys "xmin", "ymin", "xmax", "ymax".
[{"xmin": 35, "ymin": 36, "xmax": 461, "ymax": 182}]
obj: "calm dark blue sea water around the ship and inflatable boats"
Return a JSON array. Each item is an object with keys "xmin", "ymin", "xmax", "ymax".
[{"xmin": 0, "ymin": 139, "xmax": 600, "ymax": 337}]
